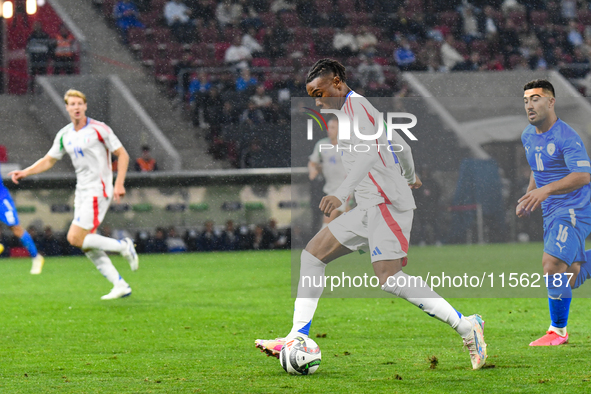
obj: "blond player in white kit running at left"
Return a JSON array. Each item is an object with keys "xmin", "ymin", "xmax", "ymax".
[{"xmin": 8, "ymin": 89, "xmax": 139, "ymax": 300}]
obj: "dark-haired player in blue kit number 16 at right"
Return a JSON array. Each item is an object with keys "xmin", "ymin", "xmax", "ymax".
[{"xmin": 516, "ymin": 79, "xmax": 591, "ymax": 346}]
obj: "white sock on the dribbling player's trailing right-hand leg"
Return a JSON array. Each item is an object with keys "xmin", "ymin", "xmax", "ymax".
[{"xmin": 382, "ymin": 271, "xmax": 472, "ymax": 338}]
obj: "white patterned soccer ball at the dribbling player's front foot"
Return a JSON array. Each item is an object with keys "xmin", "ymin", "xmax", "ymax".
[{"xmin": 279, "ymin": 337, "xmax": 321, "ymax": 375}]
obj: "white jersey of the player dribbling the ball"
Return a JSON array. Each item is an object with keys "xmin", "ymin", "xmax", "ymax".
[{"xmin": 335, "ymin": 91, "xmax": 416, "ymax": 211}]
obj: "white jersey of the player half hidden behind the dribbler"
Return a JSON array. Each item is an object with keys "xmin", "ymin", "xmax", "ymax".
[{"xmin": 309, "ymin": 137, "xmax": 347, "ymax": 195}]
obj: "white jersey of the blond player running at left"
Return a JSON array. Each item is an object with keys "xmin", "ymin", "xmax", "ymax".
[{"xmin": 47, "ymin": 118, "xmax": 122, "ymax": 197}]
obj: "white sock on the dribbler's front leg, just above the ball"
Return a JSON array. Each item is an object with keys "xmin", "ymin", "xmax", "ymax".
[{"xmin": 287, "ymin": 250, "xmax": 326, "ymax": 338}]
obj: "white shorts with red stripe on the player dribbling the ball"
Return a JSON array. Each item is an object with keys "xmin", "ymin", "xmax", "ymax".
[{"xmin": 328, "ymin": 204, "xmax": 413, "ymax": 263}]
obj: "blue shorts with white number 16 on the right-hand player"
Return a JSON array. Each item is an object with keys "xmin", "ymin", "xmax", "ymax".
[{"xmin": 544, "ymin": 206, "xmax": 591, "ymax": 266}]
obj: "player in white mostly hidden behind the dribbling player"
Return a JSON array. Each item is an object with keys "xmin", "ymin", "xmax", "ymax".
[{"xmin": 308, "ymin": 118, "xmax": 348, "ymax": 230}]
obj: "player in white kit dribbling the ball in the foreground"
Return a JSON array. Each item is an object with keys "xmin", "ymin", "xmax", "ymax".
[{"xmin": 255, "ymin": 59, "xmax": 487, "ymax": 369}]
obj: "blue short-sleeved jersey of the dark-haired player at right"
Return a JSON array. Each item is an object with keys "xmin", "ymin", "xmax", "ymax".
[{"xmin": 521, "ymin": 119, "xmax": 591, "ymax": 218}]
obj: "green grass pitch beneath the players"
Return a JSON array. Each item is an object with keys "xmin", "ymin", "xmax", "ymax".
[{"xmin": 0, "ymin": 244, "xmax": 591, "ymax": 394}]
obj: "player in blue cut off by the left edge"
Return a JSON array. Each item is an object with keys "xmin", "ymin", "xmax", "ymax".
[{"xmin": 0, "ymin": 167, "xmax": 45, "ymax": 275}]
